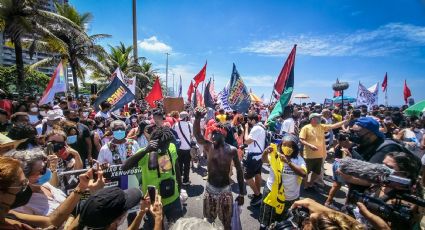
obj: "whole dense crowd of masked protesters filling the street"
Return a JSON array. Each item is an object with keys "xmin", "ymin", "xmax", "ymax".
[{"xmin": 0, "ymin": 88, "xmax": 425, "ymax": 229}]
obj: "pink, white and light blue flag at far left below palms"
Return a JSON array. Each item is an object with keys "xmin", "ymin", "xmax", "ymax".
[{"xmin": 38, "ymin": 62, "xmax": 66, "ymax": 105}]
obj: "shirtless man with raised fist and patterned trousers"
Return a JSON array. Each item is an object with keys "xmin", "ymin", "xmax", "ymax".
[{"xmin": 193, "ymin": 108, "xmax": 246, "ymax": 229}]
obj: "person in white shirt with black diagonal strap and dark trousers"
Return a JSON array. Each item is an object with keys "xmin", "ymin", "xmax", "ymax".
[{"xmin": 173, "ymin": 111, "xmax": 195, "ymax": 185}]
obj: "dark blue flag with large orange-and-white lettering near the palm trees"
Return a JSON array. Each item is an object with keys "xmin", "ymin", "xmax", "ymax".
[{"xmin": 93, "ymin": 77, "xmax": 134, "ymax": 111}]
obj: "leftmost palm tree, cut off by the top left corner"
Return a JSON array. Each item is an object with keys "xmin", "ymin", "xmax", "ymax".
[{"xmin": 0, "ymin": 0, "xmax": 77, "ymax": 92}]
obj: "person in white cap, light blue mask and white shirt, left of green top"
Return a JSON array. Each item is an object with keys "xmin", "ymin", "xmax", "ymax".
[{"xmin": 97, "ymin": 120, "xmax": 139, "ymax": 165}]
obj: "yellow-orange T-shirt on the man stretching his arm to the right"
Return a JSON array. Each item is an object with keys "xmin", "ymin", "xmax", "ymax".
[{"xmin": 300, "ymin": 124, "xmax": 331, "ymax": 159}]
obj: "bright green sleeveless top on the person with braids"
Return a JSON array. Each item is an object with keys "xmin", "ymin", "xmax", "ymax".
[{"xmin": 139, "ymin": 143, "xmax": 180, "ymax": 205}]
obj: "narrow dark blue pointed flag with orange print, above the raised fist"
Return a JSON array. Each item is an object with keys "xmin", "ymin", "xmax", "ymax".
[{"xmin": 227, "ymin": 63, "xmax": 251, "ymax": 113}]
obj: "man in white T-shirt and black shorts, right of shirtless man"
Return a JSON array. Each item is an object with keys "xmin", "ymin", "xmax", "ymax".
[{"xmin": 243, "ymin": 112, "xmax": 266, "ymax": 206}]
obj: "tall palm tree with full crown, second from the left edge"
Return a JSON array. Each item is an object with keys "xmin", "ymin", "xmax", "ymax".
[{"xmin": 31, "ymin": 3, "xmax": 110, "ymax": 97}]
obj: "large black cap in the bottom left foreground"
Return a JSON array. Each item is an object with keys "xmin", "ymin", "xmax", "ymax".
[{"xmin": 79, "ymin": 187, "xmax": 143, "ymax": 228}]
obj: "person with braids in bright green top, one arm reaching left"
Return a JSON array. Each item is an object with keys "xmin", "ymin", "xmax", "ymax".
[{"xmin": 122, "ymin": 126, "xmax": 182, "ymax": 229}]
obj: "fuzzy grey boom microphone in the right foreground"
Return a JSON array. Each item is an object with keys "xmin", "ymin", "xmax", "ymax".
[{"xmin": 339, "ymin": 157, "xmax": 411, "ymax": 187}]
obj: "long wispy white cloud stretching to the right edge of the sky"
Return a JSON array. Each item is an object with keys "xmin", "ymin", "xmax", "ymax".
[{"xmin": 240, "ymin": 23, "xmax": 425, "ymax": 57}]
